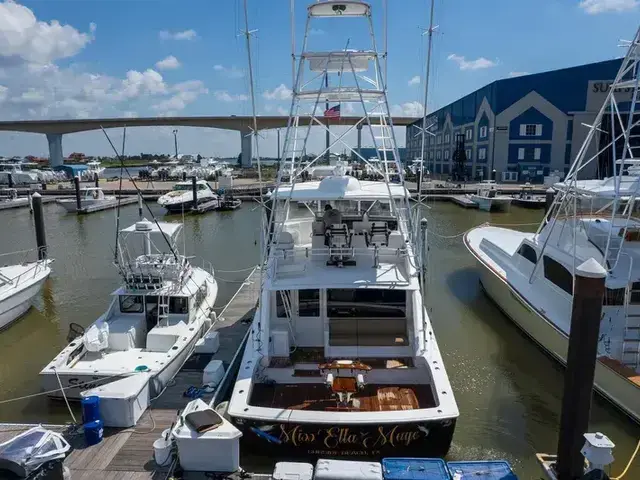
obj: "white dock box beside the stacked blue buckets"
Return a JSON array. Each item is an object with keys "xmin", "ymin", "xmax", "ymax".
[{"xmin": 82, "ymin": 372, "xmax": 151, "ymax": 428}]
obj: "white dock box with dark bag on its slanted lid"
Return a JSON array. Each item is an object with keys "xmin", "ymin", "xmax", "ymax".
[{"xmin": 173, "ymin": 399, "xmax": 242, "ymax": 473}]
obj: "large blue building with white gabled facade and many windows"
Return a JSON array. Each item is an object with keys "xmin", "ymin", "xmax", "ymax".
[{"xmin": 406, "ymin": 59, "xmax": 631, "ymax": 183}]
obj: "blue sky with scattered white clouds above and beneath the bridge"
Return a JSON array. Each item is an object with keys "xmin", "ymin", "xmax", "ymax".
[{"xmin": 0, "ymin": 0, "xmax": 640, "ymax": 156}]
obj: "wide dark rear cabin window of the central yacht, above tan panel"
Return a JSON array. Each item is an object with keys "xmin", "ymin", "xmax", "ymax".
[{"xmin": 327, "ymin": 288, "xmax": 406, "ymax": 318}]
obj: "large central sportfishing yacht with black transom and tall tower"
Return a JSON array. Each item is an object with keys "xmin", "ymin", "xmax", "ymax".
[{"xmin": 227, "ymin": 1, "xmax": 458, "ymax": 457}]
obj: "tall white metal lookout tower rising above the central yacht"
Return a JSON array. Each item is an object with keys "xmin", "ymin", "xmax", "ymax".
[{"xmin": 269, "ymin": 0, "xmax": 412, "ymax": 251}]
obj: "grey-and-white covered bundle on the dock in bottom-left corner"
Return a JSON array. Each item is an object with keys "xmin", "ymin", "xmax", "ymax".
[{"xmin": 0, "ymin": 426, "xmax": 71, "ymax": 478}]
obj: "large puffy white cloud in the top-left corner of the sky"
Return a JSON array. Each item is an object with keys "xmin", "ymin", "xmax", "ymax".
[{"xmin": 0, "ymin": 1, "xmax": 96, "ymax": 66}]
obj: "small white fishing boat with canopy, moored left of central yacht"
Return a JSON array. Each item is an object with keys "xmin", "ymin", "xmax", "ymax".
[{"xmin": 40, "ymin": 219, "xmax": 218, "ymax": 399}]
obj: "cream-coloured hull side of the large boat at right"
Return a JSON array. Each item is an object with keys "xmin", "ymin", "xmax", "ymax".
[{"xmin": 467, "ymin": 245, "xmax": 640, "ymax": 423}]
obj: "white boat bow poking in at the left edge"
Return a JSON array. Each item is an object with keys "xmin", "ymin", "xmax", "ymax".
[{"xmin": 0, "ymin": 255, "xmax": 51, "ymax": 330}]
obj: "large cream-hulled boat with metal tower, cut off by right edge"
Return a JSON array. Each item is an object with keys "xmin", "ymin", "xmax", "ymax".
[{"xmin": 464, "ymin": 30, "xmax": 640, "ymax": 423}]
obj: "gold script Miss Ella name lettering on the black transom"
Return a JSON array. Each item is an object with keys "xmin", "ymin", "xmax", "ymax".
[{"xmin": 280, "ymin": 425, "xmax": 423, "ymax": 449}]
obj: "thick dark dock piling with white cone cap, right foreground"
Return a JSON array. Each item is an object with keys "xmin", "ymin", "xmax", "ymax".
[{"xmin": 555, "ymin": 258, "xmax": 607, "ymax": 480}]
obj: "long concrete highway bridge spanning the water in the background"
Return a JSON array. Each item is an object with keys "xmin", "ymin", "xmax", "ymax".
[{"xmin": 0, "ymin": 115, "xmax": 417, "ymax": 166}]
